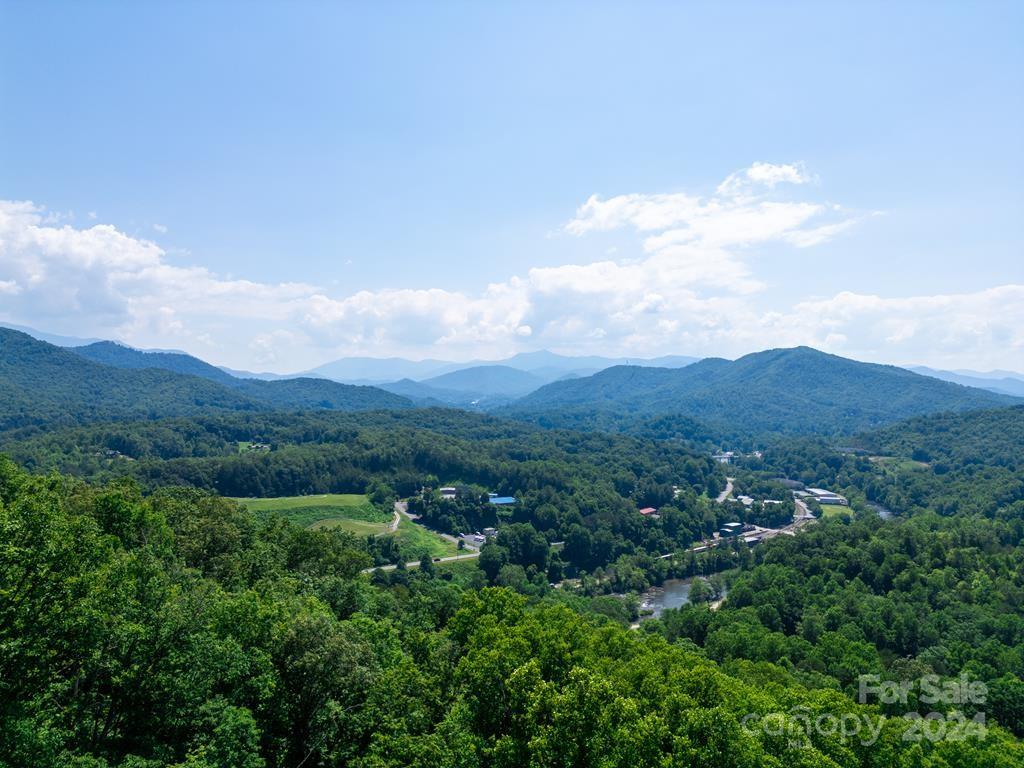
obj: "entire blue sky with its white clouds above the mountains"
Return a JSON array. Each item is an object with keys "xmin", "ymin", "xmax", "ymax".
[{"xmin": 0, "ymin": 2, "xmax": 1024, "ymax": 371}]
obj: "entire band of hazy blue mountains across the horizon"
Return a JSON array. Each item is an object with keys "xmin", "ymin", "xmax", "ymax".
[{"xmin": 0, "ymin": 329, "xmax": 1020, "ymax": 444}]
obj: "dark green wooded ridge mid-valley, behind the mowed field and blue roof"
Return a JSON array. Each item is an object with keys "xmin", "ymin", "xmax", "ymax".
[{"xmin": 0, "ymin": 410, "xmax": 725, "ymax": 577}]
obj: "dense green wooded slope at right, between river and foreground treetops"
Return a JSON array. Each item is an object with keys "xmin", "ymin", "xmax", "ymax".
[{"xmin": 650, "ymin": 513, "xmax": 1024, "ymax": 735}]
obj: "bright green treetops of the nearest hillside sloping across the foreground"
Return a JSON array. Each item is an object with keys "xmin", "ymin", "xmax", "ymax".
[{"xmin": 0, "ymin": 461, "xmax": 1024, "ymax": 768}]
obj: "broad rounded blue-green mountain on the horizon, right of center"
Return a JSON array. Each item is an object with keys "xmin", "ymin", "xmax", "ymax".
[{"xmin": 498, "ymin": 347, "xmax": 1019, "ymax": 434}]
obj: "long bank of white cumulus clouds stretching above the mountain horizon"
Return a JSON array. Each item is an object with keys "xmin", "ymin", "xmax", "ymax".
[{"xmin": 0, "ymin": 163, "xmax": 1024, "ymax": 371}]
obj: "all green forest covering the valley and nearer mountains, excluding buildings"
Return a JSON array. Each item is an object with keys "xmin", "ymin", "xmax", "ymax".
[{"xmin": 0, "ymin": 332, "xmax": 1024, "ymax": 768}]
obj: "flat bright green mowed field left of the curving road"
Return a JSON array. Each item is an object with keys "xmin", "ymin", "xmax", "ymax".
[{"xmin": 234, "ymin": 494, "xmax": 391, "ymax": 536}]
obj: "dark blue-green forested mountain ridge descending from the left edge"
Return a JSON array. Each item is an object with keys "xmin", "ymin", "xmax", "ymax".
[{"xmin": 0, "ymin": 328, "xmax": 413, "ymax": 430}]
